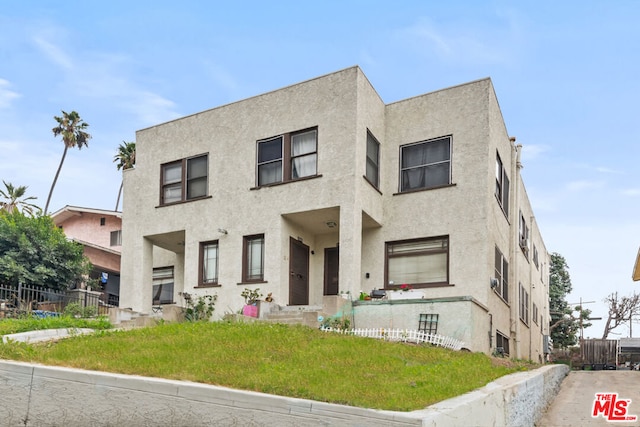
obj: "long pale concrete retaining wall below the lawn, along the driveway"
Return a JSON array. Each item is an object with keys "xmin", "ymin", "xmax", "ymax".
[{"xmin": 0, "ymin": 361, "xmax": 568, "ymax": 427}]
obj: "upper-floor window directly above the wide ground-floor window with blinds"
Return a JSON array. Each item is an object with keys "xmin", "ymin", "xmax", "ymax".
[{"xmin": 400, "ymin": 136, "xmax": 451, "ymax": 191}]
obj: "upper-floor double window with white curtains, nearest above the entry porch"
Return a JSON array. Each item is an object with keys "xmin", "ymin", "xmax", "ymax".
[{"xmin": 257, "ymin": 129, "xmax": 318, "ymax": 187}]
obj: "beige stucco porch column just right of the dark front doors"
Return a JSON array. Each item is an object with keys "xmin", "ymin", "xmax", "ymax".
[{"xmin": 340, "ymin": 206, "xmax": 362, "ymax": 299}]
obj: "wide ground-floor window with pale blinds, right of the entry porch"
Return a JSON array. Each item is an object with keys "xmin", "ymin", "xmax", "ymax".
[{"xmin": 386, "ymin": 236, "xmax": 449, "ymax": 288}]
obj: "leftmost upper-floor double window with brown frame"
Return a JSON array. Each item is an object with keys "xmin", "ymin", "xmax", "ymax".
[{"xmin": 160, "ymin": 154, "xmax": 208, "ymax": 205}]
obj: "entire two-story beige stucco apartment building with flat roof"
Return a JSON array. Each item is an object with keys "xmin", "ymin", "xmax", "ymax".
[{"xmin": 120, "ymin": 67, "xmax": 549, "ymax": 361}]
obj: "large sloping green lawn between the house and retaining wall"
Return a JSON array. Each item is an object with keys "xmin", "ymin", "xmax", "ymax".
[{"xmin": 0, "ymin": 321, "xmax": 532, "ymax": 411}]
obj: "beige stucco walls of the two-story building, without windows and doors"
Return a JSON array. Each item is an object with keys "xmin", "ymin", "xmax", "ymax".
[{"xmin": 121, "ymin": 67, "xmax": 546, "ymax": 360}]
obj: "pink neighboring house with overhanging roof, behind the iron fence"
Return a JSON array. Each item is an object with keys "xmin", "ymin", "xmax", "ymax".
[{"xmin": 51, "ymin": 205, "xmax": 122, "ymax": 305}]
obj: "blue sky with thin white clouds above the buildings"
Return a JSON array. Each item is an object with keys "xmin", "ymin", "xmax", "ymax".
[{"xmin": 0, "ymin": 0, "xmax": 640, "ymax": 337}]
